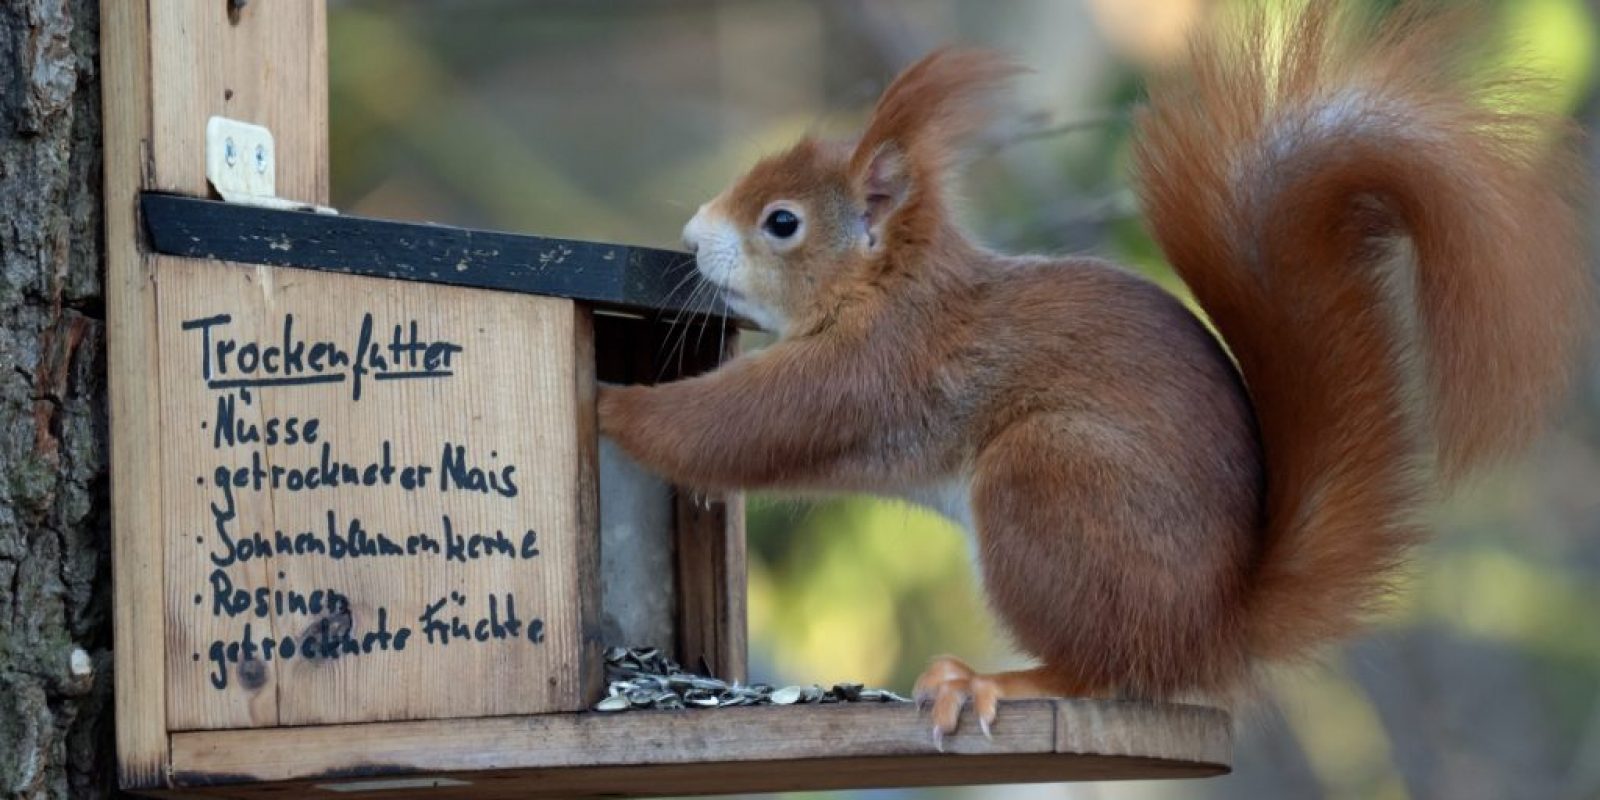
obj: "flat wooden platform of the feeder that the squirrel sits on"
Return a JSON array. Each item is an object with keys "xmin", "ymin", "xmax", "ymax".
[{"xmin": 162, "ymin": 699, "xmax": 1232, "ymax": 798}]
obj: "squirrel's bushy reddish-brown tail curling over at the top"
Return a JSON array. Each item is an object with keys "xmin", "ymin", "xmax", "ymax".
[{"xmin": 1134, "ymin": 2, "xmax": 1589, "ymax": 659}]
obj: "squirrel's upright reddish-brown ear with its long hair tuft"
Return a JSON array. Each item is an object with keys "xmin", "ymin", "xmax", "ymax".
[{"xmin": 850, "ymin": 48, "xmax": 1022, "ymax": 224}]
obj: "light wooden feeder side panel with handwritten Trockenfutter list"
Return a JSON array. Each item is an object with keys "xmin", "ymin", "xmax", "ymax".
[{"xmin": 157, "ymin": 258, "xmax": 597, "ymax": 730}]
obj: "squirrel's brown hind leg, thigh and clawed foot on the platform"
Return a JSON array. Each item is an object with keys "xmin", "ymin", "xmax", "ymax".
[{"xmin": 918, "ymin": 414, "xmax": 1254, "ymax": 723}]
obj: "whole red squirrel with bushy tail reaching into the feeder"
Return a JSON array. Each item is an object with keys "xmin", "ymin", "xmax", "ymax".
[{"xmin": 598, "ymin": 2, "xmax": 1590, "ymax": 736}]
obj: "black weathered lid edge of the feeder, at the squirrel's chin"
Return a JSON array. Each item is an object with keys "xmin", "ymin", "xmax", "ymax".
[{"xmin": 141, "ymin": 192, "xmax": 726, "ymax": 314}]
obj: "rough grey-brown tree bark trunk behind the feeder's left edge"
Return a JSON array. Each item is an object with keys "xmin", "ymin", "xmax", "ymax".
[{"xmin": 0, "ymin": 0, "xmax": 115, "ymax": 798}]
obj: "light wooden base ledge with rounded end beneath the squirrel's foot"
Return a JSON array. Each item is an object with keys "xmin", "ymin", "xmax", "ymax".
[{"xmin": 171, "ymin": 699, "xmax": 1232, "ymax": 794}]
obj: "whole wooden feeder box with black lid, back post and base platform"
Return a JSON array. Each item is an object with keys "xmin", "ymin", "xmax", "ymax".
[{"xmin": 101, "ymin": 0, "xmax": 1230, "ymax": 798}]
